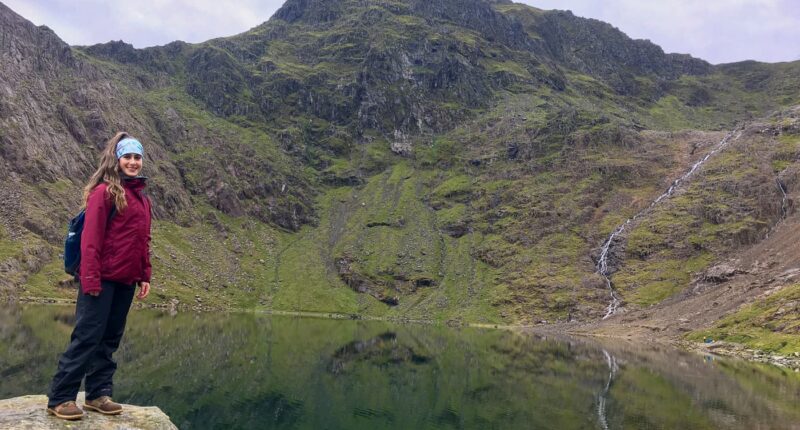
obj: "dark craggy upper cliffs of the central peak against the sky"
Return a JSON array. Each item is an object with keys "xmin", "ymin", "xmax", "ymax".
[{"xmin": 73, "ymin": 0, "xmax": 710, "ymax": 137}]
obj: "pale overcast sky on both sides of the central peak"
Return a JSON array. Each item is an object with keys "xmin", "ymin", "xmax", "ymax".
[{"xmin": 6, "ymin": 0, "xmax": 800, "ymax": 64}]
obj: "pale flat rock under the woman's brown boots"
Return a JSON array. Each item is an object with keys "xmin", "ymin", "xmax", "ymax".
[{"xmin": 0, "ymin": 392, "xmax": 178, "ymax": 430}]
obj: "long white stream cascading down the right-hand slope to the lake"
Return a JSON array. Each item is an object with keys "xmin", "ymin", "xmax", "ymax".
[{"xmin": 596, "ymin": 127, "xmax": 744, "ymax": 319}]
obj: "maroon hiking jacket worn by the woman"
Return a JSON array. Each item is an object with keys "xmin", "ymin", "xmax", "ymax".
[{"xmin": 79, "ymin": 178, "xmax": 151, "ymax": 294}]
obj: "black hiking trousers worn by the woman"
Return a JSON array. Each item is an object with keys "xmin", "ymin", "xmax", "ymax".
[{"xmin": 47, "ymin": 281, "xmax": 136, "ymax": 408}]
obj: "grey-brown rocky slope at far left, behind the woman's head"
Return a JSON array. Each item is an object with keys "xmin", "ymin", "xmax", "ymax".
[{"xmin": 0, "ymin": 0, "xmax": 314, "ymax": 292}]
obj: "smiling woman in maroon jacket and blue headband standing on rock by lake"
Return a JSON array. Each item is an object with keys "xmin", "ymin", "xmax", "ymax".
[{"xmin": 47, "ymin": 133, "xmax": 150, "ymax": 420}]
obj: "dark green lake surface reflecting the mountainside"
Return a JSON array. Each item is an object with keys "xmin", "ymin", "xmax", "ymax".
[{"xmin": 0, "ymin": 305, "xmax": 800, "ymax": 429}]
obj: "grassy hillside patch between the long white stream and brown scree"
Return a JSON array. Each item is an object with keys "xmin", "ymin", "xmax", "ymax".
[{"xmin": 613, "ymin": 126, "xmax": 796, "ymax": 306}]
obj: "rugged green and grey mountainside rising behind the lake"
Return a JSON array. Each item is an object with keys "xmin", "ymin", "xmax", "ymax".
[{"xmin": 0, "ymin": 0, "xmax": 800, "ymax": 348}]
